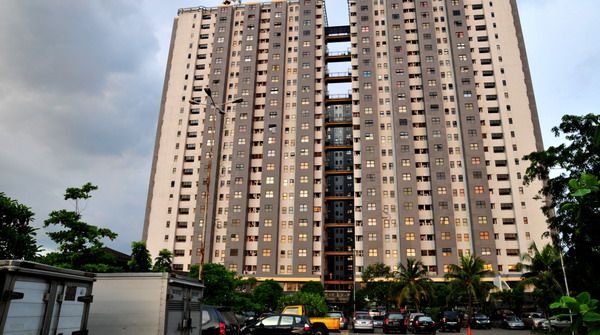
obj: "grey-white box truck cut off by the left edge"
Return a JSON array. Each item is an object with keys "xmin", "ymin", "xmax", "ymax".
[{"xmin": 0, "ymin": 260, "xmax": 95, "ymax": 335}]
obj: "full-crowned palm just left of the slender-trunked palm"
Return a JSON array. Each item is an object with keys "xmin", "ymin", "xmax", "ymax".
[{"xmin": 391, "ymin": 258, "xmax": 433, "ymax": 312}]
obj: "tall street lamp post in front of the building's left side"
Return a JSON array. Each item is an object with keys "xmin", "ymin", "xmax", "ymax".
[{"xmin": 189, "ymin": 87, "xmax": 244, "ymax": 281}]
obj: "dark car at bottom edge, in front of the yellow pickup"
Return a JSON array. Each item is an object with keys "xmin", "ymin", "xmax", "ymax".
[{"xmin": 240, "ymin": 314, "xmax": 312, "ymax": 335}]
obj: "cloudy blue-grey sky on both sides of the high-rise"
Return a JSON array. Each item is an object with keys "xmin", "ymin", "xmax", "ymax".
[{"xmin": 0, "ymin": 0, "xmax": 600, "ymax": 253}]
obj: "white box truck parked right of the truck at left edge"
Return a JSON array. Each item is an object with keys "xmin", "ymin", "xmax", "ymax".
[{"xmin": 88, "ymin": 272, "xmax": 204, "ymax": 335}]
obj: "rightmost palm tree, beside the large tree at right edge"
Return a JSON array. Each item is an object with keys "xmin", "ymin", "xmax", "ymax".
[{"xmin": 517, "ymin": 242, "xmax": 566, "ymax": 314}]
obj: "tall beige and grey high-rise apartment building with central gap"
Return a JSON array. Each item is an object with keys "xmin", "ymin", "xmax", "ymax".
[{"xmin": 144, "ymin": 0, "xmax": 546, "ymax": 300}]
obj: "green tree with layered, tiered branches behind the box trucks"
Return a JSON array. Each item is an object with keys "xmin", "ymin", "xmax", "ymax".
[{"xmin": 39, "ymin": 183, "xmax": 122, "ymax": 272}]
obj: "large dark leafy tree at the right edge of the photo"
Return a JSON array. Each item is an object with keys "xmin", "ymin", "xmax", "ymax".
[{"xmin": 524, "ymin": 114, "xmax": 600, "ymax": 296}]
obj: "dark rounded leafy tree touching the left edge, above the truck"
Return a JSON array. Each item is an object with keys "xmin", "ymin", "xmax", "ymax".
[{"xmin": 0, "ymin": 192, "xmax": 40, "ymax": 260}]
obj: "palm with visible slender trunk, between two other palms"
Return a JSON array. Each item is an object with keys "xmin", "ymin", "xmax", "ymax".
[{"xmin": 444, "ymin": 255, "xmax": 494, "ymax": 324}]
